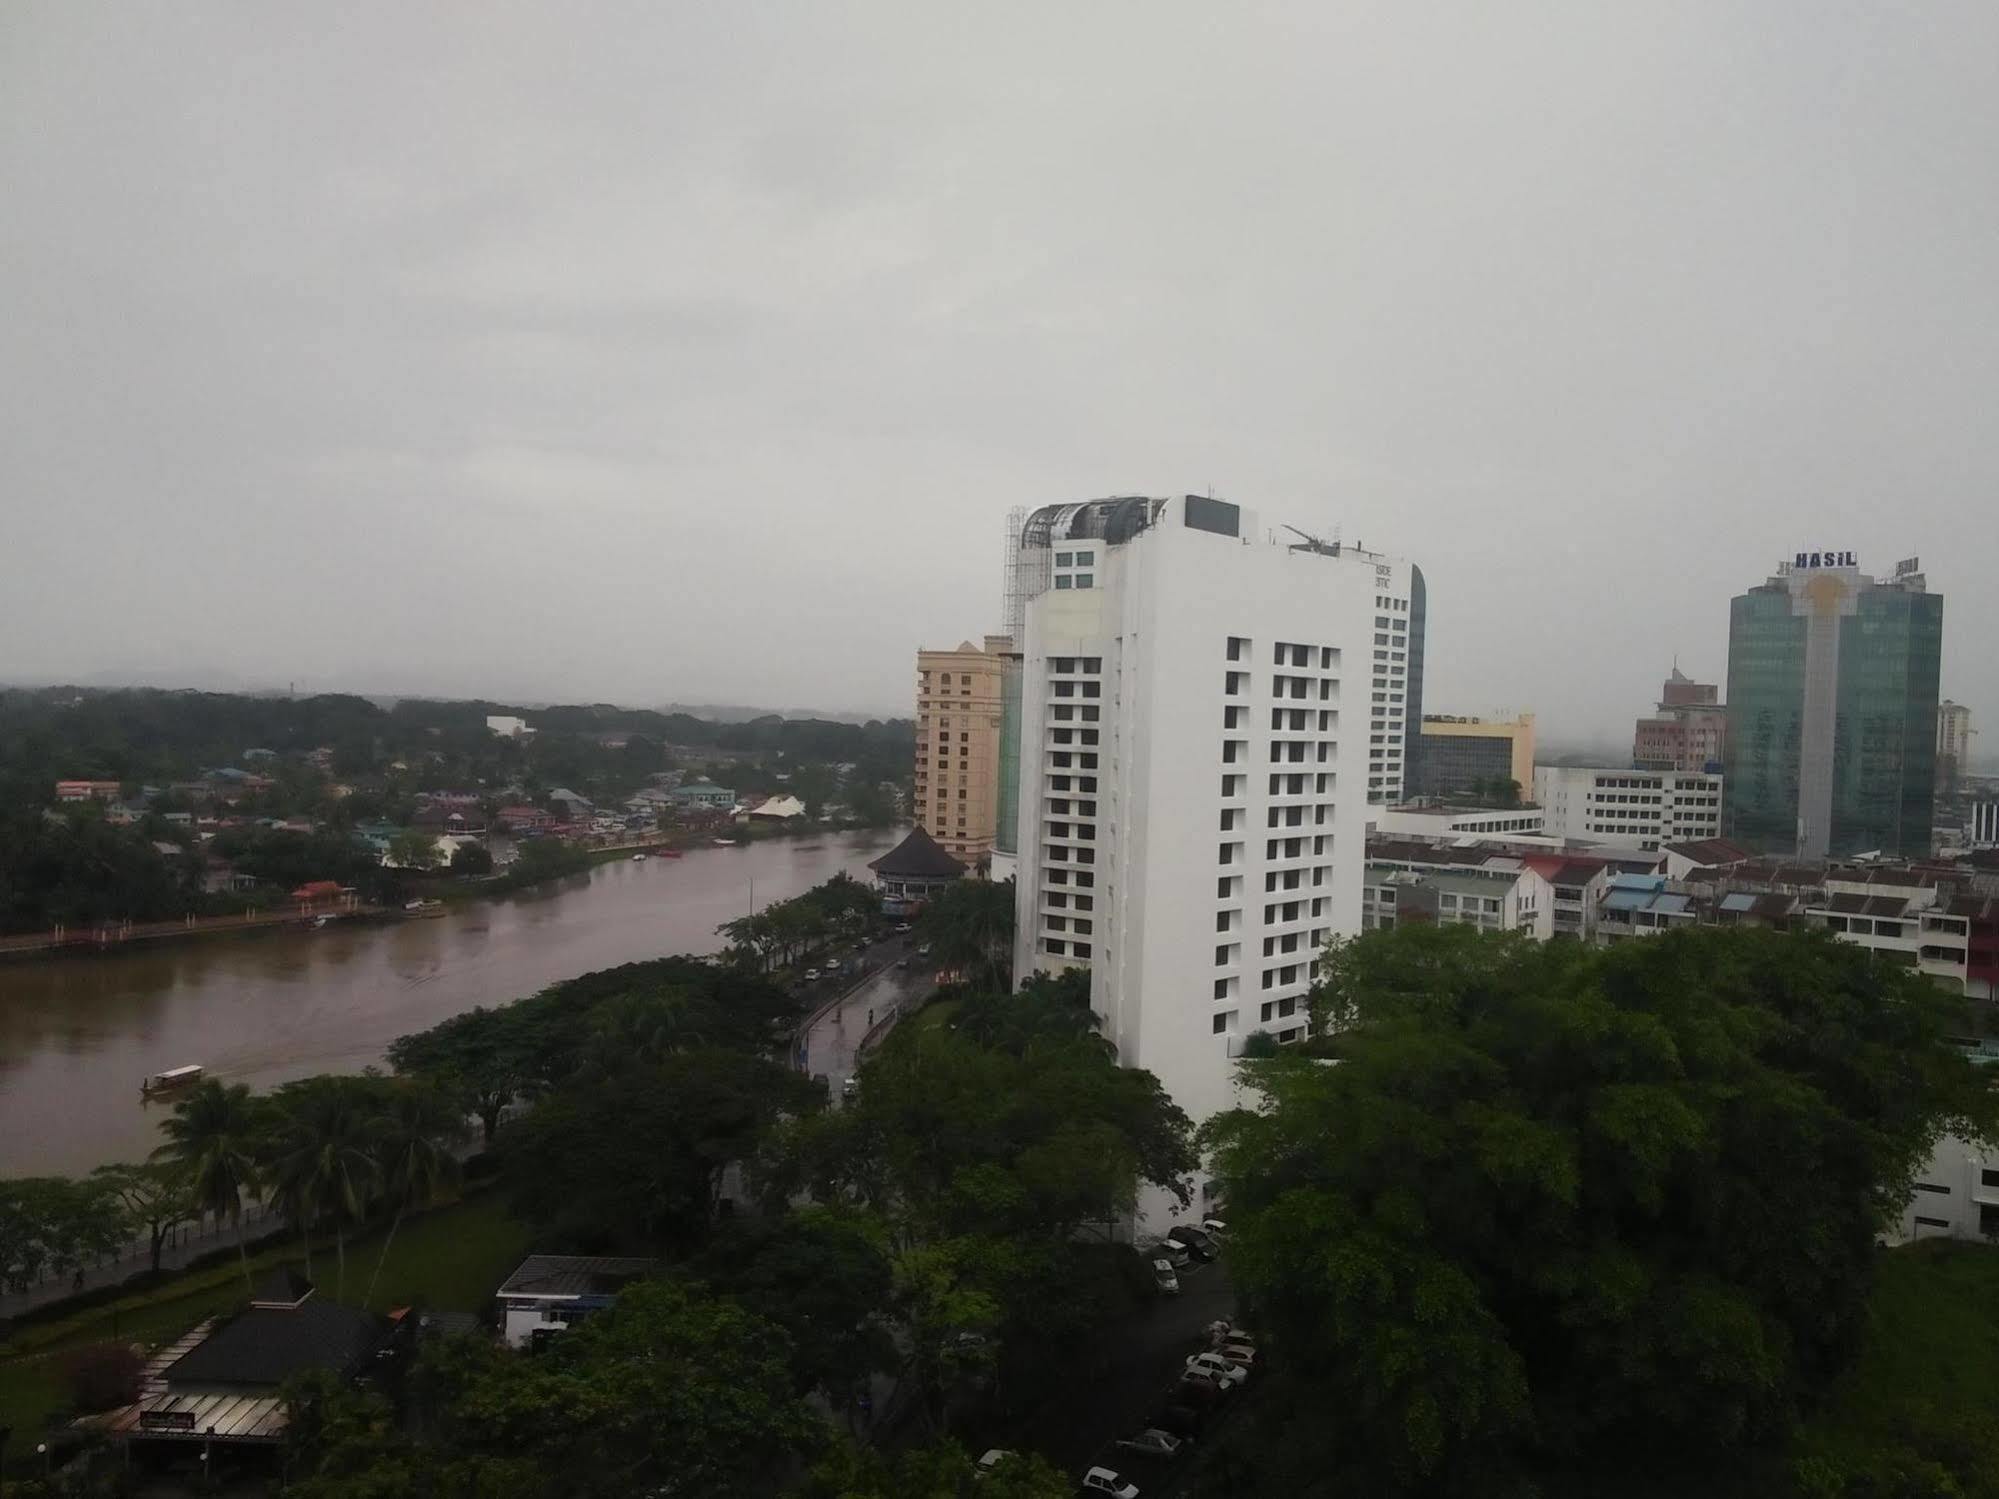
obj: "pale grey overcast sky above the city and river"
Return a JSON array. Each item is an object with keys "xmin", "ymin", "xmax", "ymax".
[{"xmin": 0, "ymin": 0, "xmax": 1999, "ymax": 744}]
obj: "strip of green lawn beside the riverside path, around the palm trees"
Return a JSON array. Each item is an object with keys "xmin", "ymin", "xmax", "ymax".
[{"xmin": 0, "ymin": 1191, "xmax": 528, "ymax": 1463}]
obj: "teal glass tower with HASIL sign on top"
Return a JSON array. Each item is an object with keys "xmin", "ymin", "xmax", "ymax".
[{"xmin": 1723, "ymin": 552, "xmax": 1943, "ymax": 859}]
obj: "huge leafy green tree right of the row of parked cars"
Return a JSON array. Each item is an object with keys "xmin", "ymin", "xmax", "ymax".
[{"xmin": 1207, "ymin": 925, "xmax": 1995, "ymax": 1495}]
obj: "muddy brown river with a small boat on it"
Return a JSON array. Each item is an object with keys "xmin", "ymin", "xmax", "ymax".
[{"xmin": 0, "ymin": 833, "xmax": 896, "ymax": 1177}]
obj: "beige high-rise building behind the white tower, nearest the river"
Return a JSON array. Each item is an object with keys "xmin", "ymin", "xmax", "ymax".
[{"xmin": 916, "ymin": 636, "xmax": 1013, "ymax": 865}]
